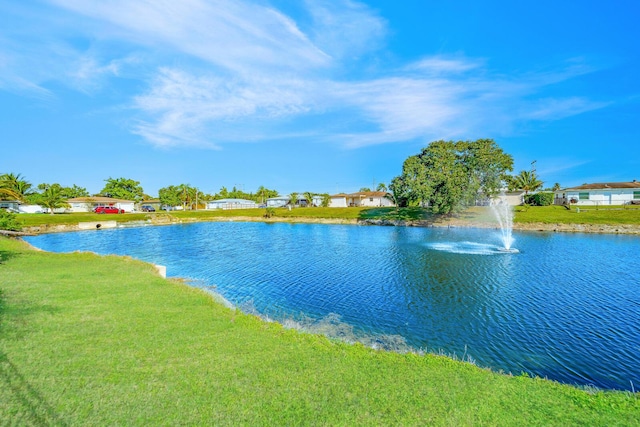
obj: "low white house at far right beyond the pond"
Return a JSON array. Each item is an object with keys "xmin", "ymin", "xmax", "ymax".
[{"xmin": 554, "ymin": 180, "xmax": 640, "ymax": 206}]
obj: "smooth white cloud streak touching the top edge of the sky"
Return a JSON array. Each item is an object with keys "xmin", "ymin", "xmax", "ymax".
[{"xmin": 48, "ymin": 0, "xmax": 328, "ymax": 73}]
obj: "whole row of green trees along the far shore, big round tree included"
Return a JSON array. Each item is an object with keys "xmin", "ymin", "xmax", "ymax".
[{"xmin": 0, "ymin": 139, "xmax": 560, "ymax": 214}]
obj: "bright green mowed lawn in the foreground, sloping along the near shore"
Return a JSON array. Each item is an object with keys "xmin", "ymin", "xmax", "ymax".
[{"xmin": 0, "ymin": 238, "xmax": 640, "ymax": 426}]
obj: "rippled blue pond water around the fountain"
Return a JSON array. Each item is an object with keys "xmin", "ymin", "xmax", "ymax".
[{"xmin": 26, "ymin": 222, "xmax": 640, "ymax": 390}]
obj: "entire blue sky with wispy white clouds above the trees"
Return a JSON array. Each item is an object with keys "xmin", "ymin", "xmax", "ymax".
[{"xmin": 0, "ymin": 0, "xmax": 640, "ymax": 195}]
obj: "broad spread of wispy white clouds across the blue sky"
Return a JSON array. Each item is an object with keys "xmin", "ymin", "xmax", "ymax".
[{"xmin": 0, "ymin": 0, "xmax": 607, "ymax": 148}]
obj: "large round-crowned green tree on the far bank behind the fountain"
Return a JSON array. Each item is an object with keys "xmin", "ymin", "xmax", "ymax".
[{"xmin": 390, "ymin": 139, "xmax": 513, "ymax": 214}]
